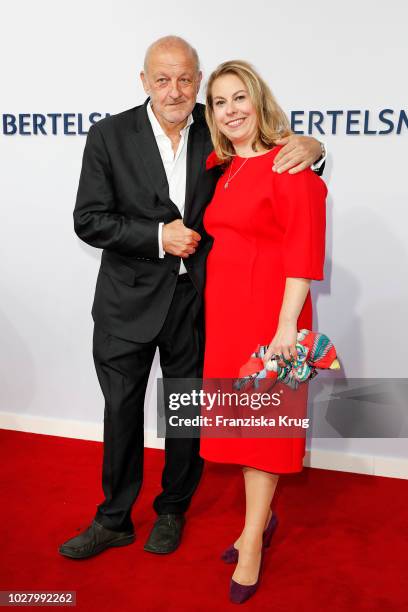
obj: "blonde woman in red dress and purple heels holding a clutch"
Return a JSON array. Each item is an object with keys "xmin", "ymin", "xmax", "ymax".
[{"xmin": 200, "ymin": 61, "xmax": 327, "ymax": 603}]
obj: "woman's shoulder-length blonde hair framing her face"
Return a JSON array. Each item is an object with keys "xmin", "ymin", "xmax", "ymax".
[{"xmin": 205, "ymin": 60, "xmax": 292, "ymax": 163}]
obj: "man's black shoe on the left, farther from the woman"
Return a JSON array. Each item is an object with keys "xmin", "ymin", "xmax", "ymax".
[{"xmin": 58, "ymin": 520, "xmax": 135, "ymax": 559}]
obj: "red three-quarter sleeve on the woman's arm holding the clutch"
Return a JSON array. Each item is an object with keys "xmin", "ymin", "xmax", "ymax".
[{"xmin": 273, "ymin": 168, "xmax": 327, "ymax": 280}]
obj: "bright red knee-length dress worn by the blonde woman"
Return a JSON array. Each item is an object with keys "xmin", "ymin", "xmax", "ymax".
[{"xmin": 200, "ymin": 147, "xmax": 327, "ymax": 473}]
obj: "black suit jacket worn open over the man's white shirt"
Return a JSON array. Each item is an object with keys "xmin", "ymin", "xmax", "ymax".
[{"xmin": 74, "ymin": 99, "xmax": 220, "ymax": 342}]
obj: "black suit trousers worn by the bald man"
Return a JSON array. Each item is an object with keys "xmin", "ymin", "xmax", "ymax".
[{"xmin": 93, "ymin": 274, "xmax": 204, "ymax": 531}]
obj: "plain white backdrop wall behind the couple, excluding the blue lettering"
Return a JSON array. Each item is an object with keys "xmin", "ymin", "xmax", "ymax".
[{"xmin": 0, "ymin": 0, "xmax": 408, "ymax": 470}]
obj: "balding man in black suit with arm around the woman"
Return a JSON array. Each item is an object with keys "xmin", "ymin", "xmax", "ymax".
[{"xmin": 59, "ymin": 36, "xmax": 321, "ymax": 559}]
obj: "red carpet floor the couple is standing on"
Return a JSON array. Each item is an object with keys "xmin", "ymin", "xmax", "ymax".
[{"xmin": 0, "ymin": 431, "xmax": 408, "ymax": 612}]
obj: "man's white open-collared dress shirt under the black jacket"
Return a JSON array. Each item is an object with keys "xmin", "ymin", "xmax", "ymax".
[{"xmin": 147, "ymin": 103, "xmax": 194, "ymax": 274}]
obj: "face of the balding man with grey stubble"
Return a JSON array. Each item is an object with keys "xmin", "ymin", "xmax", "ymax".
[{"xmin": 140, "ymin": 48, "xmax": 202, "ymax": 124}]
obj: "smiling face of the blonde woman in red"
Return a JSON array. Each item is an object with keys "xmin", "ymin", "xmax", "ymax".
[{"xmin": 212, "ymin": 74, "xmax": 258, "ymax": 144}]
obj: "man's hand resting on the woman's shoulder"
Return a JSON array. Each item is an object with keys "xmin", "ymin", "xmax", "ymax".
[{"xmin": 272, "ymin": 134, "xmax": 322, "ymax": 174}]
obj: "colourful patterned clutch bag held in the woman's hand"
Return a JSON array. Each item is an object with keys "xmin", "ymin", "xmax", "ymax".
[{"xmin": 234, "ymin": 329, "xmax": 340, "ymax": 390}]
